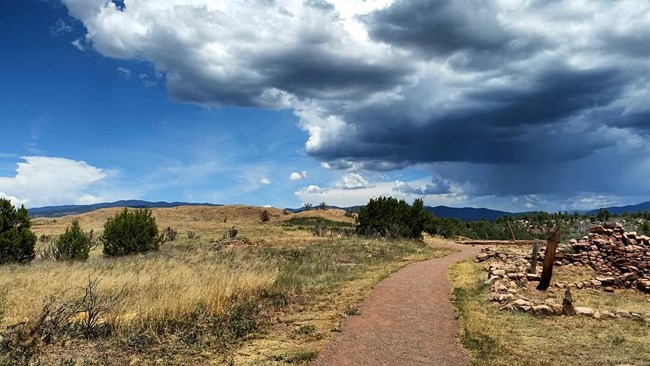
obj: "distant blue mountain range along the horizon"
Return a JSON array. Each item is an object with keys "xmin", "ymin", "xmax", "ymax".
[{"xmin": 29, "ymin": 200, "xmax": 650, "ymax": 221}]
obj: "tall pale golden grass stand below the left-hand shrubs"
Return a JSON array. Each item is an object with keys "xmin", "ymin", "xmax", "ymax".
[{"xmin": 0, "ymin": 245, "xmax": 277, "ymax": 326}]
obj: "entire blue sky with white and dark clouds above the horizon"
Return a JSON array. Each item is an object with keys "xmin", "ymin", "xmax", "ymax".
[{"xmin": 0, "ymin": 0, "xmax": 650, "ymax": 212}]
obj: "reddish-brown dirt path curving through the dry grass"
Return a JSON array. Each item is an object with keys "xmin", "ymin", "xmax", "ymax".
[{"xmin": 315, "ymin": 244, "xmax": 480, "ymax": 366}]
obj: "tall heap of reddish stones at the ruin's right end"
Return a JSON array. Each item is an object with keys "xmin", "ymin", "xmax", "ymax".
[{"xmin": 562, "ymin": 223, "xmax": 650, "ymax": 292}]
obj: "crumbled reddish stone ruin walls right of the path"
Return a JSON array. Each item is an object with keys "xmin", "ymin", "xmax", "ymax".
[{"xmin": 475, "ymin": 223, "xmax": 650, "ymax": 322}]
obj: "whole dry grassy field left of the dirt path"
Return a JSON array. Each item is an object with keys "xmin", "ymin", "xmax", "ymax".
[{"xmin": 0, "ymin": 206, "xmax": 447, "ymax": 365}]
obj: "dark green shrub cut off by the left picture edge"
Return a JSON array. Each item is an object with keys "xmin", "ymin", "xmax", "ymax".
[{"xmin": 0, "ymin": 198, "xmax": 36, "ymax": 264}]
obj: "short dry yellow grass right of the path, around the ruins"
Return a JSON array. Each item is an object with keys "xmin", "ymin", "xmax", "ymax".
[{"xmin": 450, "ymin": 262, "xmax": 650, "ymax": 366}]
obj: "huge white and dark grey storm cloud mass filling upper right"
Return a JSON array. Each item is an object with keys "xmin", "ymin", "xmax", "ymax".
[{"xmin": 64, "ymin": 0, "xmax": 650, "ymax": 202}]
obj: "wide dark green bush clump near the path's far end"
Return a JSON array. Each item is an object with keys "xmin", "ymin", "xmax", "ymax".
[{"xmin": 357, "ymin": 197, "xmax": 433, "ymax": 239}]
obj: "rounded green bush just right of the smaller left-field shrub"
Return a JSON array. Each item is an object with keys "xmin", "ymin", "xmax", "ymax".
[{"xmin": 100, "ymin": 208, "xmax": 162, "ymax": 256}]
